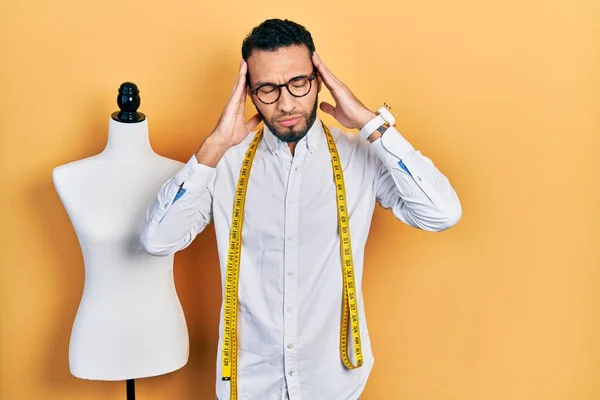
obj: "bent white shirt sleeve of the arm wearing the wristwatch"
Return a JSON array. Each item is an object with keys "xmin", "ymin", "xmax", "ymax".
[{"xmin": 372, "ymin": 127, "xmax": 462, "ymax": 231}]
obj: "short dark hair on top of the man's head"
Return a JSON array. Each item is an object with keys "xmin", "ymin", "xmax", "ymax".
[{"xmin": 242, "ymin": 19, "xmax": 315, "ymax": 61}]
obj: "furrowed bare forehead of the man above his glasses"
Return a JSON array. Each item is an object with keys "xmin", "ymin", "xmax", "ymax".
[{"xmin": 248, "ymin": 45, "xmax": 313, "ymax": 84}]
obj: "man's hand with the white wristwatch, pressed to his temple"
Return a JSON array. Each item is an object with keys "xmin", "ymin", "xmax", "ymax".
[{"xmin": 313, "ymin": 52, "xmax": 377, "ymax": 130}]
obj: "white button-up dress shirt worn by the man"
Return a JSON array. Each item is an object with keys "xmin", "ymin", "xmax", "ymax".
[{"xmin": 141, "ymin": 118, "xmax": 462, "ymax": 400}]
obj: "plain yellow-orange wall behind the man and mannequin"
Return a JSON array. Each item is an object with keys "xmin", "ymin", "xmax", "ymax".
[{"xmin": 0, "ymin": 0, "xmax": 600, "ymax": 400}]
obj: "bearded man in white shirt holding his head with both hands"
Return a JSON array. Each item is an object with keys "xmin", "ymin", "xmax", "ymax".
[{"xmin": 141, "ymin": 20, "xmax": 462, "ymax": 400}]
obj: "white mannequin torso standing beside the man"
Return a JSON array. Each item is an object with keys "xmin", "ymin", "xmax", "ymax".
[{"xmin": 52, "ymin": 92, "xmax": 189, "ymax": 380}]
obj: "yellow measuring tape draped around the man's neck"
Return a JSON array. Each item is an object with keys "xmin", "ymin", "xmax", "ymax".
[{"xmin": 222, "ymin": 124, "xmax": 363, "ymax": 400}]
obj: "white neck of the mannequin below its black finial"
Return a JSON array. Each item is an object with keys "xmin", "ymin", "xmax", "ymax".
[{"xmin": 102, "ymin": 118, "xmax": 154, "ymax": 157}]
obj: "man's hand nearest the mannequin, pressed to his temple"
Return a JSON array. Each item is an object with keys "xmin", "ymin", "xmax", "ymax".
[{"xmin": 196, "ymin": 60, "xmax": 261, "ymax": 167}]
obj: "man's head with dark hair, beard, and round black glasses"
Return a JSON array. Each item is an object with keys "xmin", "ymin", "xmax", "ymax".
[{"xmin": 242, "ymin": 19, "xmax": 321, "ymax": 142}]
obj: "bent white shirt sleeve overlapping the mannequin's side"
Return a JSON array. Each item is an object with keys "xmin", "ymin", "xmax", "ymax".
[{"xmin": 140, "ymin": 155, "xmax": 215, "ymax": 256}]
